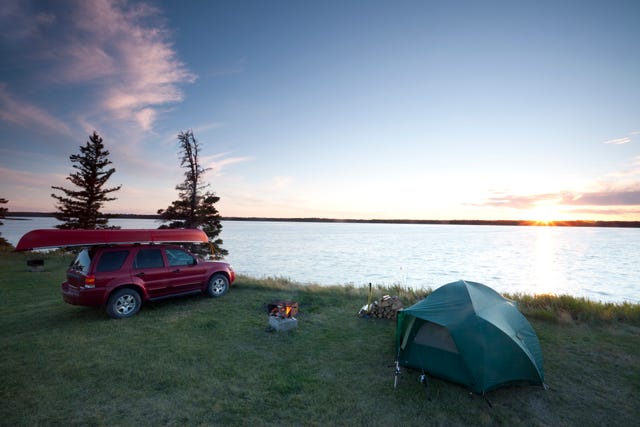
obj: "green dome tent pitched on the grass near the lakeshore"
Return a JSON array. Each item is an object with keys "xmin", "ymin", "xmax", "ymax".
[{"xmin": 396, "ymin": 280, "xmax": 544, "ymax": 393}]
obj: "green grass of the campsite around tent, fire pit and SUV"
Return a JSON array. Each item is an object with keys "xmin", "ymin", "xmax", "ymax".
[{"xmin": 0, "ymin": 253, "xmax": 640, "ymax": 426}]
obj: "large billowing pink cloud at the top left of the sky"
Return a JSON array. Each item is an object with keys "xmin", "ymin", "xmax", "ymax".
[{"xmin": 0, "ymin": 0, "xmax": 196, "ymax": 131}]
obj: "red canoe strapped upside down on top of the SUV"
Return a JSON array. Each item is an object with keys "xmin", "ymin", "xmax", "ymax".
[{"xmin": 16, "ymin": 228, "xmax": 209, "ymax": 251}]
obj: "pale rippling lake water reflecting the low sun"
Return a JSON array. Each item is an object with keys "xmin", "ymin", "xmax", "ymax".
[{"xmin": 0, "ymin": 217, "xmax": 640, "ymax": 303}]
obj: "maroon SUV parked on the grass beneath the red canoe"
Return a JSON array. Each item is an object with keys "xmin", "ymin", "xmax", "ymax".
[{"xmin": 62, "ymin": 244, "xmax": 235, "ymax": 319}]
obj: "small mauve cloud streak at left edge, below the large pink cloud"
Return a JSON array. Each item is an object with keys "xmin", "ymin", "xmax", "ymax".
[{"xmin": 0, "ymin": 84, "xmax": 72, "ymax": 135}]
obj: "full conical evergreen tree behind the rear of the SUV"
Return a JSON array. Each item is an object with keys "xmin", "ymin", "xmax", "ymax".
[{"xmin": 51, "ymin": 131, "xmax": 122, "ymax": 230}]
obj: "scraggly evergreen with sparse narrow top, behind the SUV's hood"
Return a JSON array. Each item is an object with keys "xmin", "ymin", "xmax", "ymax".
[{"xmin": 158, "ymin": 130, "xmax": 229, "ymax": 259}]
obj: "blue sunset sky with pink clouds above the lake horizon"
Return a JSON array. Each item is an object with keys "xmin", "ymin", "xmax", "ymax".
[{"xmin": 0, "ymin": 0, "xmax": 640, "ymax": 221}]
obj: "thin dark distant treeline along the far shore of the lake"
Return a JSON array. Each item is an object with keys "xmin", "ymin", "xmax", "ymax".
[{"xmin": 7, "ymin": 212, "xmax": 640, "ymax": 228}]
